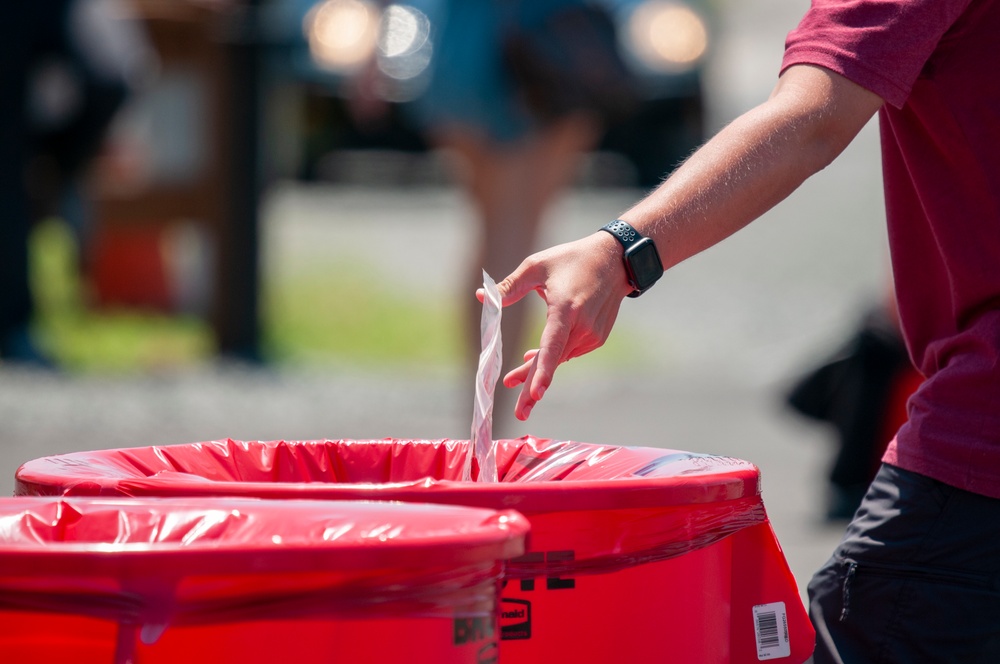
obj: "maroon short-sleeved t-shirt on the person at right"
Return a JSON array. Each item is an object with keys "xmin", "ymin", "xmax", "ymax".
[{"xmin": 782, "ymin": 0, "xmax": 1000, "ymax": 498}]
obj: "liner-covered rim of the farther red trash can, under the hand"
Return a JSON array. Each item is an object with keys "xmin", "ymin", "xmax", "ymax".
[{"xmin": 15, "ymin": 436, "xmax": 760, "ymax": 514}]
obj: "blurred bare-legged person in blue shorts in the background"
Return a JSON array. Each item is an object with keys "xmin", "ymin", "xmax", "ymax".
[{"xmin": 394, "ymin": 0, "xmax": 620, "ymax": 435}]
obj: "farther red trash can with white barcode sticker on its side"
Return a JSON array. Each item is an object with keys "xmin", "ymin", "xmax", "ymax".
[{"xmin": 15, "ymin": 437, "xmax": 815, "ymax": 664}]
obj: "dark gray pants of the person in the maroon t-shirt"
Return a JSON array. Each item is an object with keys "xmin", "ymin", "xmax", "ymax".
[{"xmin": 809, "ymin": 465, "xmax": 1000, "ymax": 664}]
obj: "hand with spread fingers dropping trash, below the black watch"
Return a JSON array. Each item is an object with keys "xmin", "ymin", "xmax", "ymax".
[{"xmin": 477, "ymin": 231, "xmax": 632, "ymax": 420}]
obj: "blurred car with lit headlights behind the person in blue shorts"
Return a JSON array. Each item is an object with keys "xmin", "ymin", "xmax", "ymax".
[{"xmin": 267, "ymin": 0, "xmax": 713, "ymax": 186}]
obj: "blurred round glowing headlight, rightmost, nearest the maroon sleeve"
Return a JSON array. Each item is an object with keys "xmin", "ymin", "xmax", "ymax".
[{"xmin": 625, "ymin": 0, "xmax": 708, "ymax": 73}]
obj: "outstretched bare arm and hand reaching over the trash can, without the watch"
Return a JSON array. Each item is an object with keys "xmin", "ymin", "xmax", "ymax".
[{"xmin": 497, "ymin": 65, "xmax": 882, "ymax": 420}]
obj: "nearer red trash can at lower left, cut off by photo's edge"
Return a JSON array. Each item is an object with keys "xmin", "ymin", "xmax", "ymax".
[{"xmin": 0, "ymin": 497, "xmax": 528, "ymax": 664}]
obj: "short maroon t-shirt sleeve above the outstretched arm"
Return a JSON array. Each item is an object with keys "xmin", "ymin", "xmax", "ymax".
[{"xmin": 781, "ymin": 0, "xmax": 970, "ymax": 108}]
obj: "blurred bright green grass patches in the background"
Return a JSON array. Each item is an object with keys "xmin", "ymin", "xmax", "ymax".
[{"xmin": 31, "ymin": 220, "xmax": 635, "ymax": 373}]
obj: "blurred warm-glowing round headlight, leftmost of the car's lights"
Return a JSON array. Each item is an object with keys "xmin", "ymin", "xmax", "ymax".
[{"xmin": 302, "ymin": 0, "xmax": 379, "ymax": 73}]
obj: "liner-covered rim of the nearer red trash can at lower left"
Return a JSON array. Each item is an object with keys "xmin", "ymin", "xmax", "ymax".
[{"xmin": 0, "ymin": 496, "xmax": 529, "ymax": 576}]
